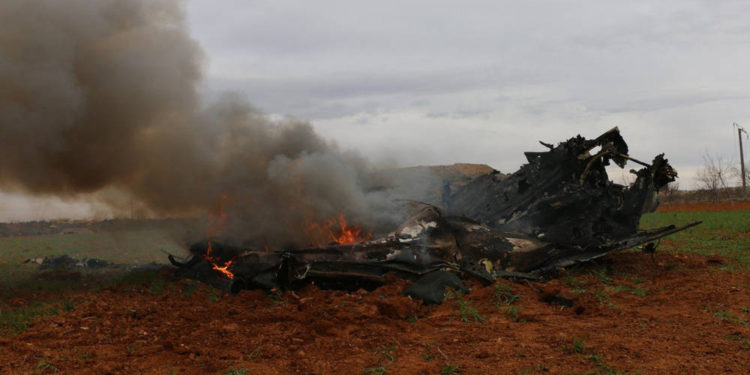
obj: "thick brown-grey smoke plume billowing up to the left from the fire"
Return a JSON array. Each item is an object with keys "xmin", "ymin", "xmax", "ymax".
[{"xmin": 0, "ymin": 0, "xmax": 424, "ymax": 244}]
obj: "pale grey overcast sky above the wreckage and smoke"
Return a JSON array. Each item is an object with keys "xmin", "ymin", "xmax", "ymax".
[{"xmin": 1, "ymin": 0, "xmax": 750, "ymax": 220}]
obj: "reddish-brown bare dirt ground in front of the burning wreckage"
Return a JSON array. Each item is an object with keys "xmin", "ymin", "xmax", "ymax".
[{"xmin": 0, "ymin": 206, "xmax": 750, "ymax": 374}]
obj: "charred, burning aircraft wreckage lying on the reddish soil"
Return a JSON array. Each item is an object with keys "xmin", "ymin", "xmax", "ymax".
[{"xmin": 169, "ymin": 128, "xmax": 699, "ymax": 303}]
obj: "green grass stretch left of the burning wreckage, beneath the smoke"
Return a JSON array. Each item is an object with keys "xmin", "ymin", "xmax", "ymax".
[{"xmin": 0, "ymin": 227, "xmax": 191, "ymax": 305}]
